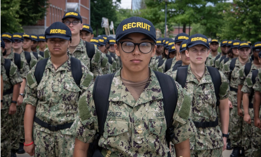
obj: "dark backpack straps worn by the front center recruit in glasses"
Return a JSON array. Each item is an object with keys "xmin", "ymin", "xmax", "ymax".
[{"xmin": 88, "ymin": 71, "xmax": 178, "ymax": 156}]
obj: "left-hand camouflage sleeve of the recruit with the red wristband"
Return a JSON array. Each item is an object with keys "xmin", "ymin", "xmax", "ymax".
[{"xmin": 24, "ymin": 67, "xmax": 38, "ymax": 106}]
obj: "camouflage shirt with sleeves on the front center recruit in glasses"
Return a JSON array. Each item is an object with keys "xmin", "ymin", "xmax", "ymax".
[{"xmin": 73, "ymin": 70, "xmax": 191, "ymax": 157}]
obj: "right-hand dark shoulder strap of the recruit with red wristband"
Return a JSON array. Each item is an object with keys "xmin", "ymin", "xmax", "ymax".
[{"xmin": 71, "ymin": 57, "xmax": 82, "ymax": 86}]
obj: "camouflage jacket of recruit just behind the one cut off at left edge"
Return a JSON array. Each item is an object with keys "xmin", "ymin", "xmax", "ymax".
[{"xmin": 6, "ymin": 51, "xmax": 30, "ymax": 79}]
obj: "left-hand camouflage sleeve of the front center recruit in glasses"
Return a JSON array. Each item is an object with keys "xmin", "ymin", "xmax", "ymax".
[{"xmin": 72, "ymin": 84, "xmax": 98, "ymax": 143}]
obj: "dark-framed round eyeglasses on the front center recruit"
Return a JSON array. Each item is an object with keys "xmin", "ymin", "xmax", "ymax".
[{"xmin": 120, "ymin": 41, "xmax": 154, "ymax": 54}]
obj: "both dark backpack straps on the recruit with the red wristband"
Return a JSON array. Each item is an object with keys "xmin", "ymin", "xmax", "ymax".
[{"xmin": 34, "ymin": 57, "xmax": 82, "ymax": 86}]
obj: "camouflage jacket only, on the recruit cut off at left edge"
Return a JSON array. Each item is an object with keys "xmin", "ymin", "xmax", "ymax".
[{"xmin": 1, "ymin": 57, "xmax": 23, "ymax": 109}]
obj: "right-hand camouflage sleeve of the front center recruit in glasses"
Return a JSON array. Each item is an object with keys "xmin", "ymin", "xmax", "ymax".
[{"xmin": 172, "ymin": 82, "xmax": 193, "ymax": 144}]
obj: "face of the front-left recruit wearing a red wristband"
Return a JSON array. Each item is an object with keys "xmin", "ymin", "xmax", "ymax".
[{"xmin": 47, "ymin": 38, "xmax": 70, "ymax": 57}]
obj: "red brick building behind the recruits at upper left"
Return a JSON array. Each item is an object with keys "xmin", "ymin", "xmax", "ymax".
[{"xmin": 23, "ymin": 0, "xmax": 91, "ymax": 34}]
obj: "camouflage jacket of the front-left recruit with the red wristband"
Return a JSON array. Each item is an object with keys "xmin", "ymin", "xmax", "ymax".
[{"xmin": 24, "ymin": 59, "xmax": 93, "ymax": 135}]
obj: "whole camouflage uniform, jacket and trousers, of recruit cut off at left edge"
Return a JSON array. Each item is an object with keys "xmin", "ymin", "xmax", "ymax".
[{"xmin": 1, "ymin": 59, "xmax": 22, "ymax": 157}]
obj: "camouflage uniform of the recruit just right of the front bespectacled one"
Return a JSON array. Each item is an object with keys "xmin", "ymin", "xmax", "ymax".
[{"xmin": 167, "ymin": 65, "xmax": 229, "ymax": 150}]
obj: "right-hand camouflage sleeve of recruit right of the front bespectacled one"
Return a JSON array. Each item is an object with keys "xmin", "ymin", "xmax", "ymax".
[{"xmin": 219, "ymin": 72, "xmax": 229, "ymax": 100}]
